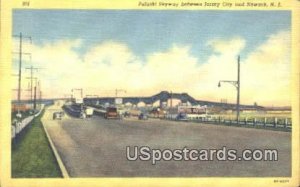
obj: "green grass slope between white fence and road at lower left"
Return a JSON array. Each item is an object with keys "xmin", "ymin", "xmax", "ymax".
[{"xmin": 12, "ymin": 114, "xmax": 62, "ymax": 178}]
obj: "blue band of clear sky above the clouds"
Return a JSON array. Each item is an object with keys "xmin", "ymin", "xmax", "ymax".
[{"xmin": 13, "ymin": 10, "xmax": 291, "ymax": 60}]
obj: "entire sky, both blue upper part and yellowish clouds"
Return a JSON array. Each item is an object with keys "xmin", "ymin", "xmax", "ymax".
[{"xmin": 13, "ymin": 10, "xmax": 291, "ymax": 106}]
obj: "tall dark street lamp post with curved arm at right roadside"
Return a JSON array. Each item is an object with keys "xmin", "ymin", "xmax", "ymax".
[{"xmin": 218, "ymin": 56, "xmax": 241, "ymax": 123}]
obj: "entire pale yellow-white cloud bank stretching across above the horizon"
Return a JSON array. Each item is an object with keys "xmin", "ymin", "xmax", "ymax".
[{"xmin": 14, "ymin": 32, "xmax": 290, "ymax": 105}]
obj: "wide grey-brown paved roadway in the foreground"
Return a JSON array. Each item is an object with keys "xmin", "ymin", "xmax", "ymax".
[{"xmin": 44, "ymin": 104, "xmax": 291, "ymax": 177}]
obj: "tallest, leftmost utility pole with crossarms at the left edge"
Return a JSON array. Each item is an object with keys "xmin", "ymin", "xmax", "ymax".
[{"xmin": 13, "ymin": 32, "xmax": 31, "ymax": 114}]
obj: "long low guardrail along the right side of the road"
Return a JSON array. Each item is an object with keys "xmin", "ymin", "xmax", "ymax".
[{"xmin": 164, "ymin": 116, "xmax": 292, "ymax": 131}]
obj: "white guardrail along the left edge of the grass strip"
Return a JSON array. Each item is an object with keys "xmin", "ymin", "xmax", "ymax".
[{"xmin": 11, "ymin": 107, "xmax": 44, "ymax": 139}]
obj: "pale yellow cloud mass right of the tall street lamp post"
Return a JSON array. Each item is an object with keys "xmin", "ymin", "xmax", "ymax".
[{"xmin": 242, "ymin": 32, "xmax": 291, "ymax": 105}]
